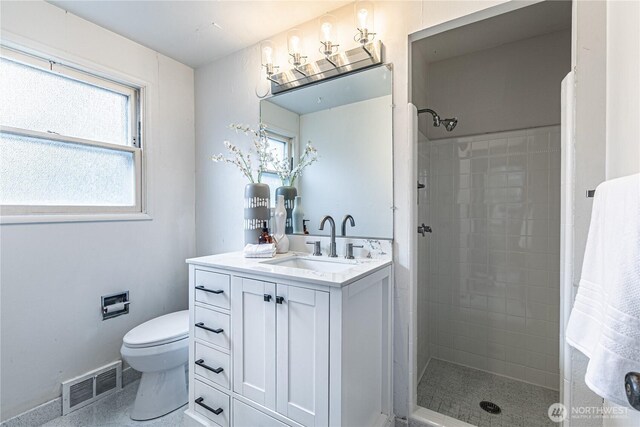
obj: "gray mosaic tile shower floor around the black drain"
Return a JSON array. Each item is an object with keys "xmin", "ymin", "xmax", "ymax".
[{"xmin": 418, "ymin": 359, "xmax": 559, "ymax": 427}]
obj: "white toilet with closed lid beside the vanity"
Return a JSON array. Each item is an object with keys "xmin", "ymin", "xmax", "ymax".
[{"xmin": 120, "ymin": 310, "xmax": 189, "ymax": 421}]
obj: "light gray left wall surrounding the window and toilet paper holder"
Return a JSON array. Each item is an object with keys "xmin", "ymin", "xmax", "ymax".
[{"xmin": 0, "ymin": 2, "xmax": 195, "ymax": 420}]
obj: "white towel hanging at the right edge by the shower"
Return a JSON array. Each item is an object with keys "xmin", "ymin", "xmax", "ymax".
[{"xmin": 566, "ymin": 174, "xmax": 640, "ymax": 406}]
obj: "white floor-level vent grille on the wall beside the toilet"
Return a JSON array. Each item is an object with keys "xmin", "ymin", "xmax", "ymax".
[{"xmin": 62, "ymin": 361, "xmax": 122, "ymax": 415}]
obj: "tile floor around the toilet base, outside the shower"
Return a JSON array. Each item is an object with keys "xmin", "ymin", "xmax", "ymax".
[{"xmin": 43, "ymin": 380, "xmax": 187, "ymax": 427}]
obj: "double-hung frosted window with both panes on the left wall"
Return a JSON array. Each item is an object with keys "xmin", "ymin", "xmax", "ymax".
[{"xmin": 0, "ymin": 47, "xmax": 142, "ymax": 215}]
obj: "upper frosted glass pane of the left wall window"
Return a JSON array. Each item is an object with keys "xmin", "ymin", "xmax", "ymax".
[{"xmin": 0, "ymin": 58, "xmax": 132, "ymax": 145}]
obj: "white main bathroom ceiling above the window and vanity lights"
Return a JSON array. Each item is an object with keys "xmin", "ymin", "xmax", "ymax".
[{"xmin": 49, "ymin": 0, "xmax": 350, "ymax": 68}]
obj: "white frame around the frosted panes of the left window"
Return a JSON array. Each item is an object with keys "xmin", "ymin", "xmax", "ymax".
[{"xmin": 0, "ymin": 44, "xmax": 144, "ymax": 224}]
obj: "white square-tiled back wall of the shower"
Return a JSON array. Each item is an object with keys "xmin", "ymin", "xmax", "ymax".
[{"xmin": 419, "ymin": 126, "xmax": 560, "ymax": 389}]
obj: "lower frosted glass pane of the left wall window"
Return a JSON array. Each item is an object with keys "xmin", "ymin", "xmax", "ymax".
[{"xmin": 0, "ymin": 132, "xmax": 136, "ymax": 206}]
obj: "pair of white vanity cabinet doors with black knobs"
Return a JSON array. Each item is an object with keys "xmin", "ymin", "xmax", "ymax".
[{"xmin": 232, "ymin": 276, "xmax": 329, "ymax": 426}]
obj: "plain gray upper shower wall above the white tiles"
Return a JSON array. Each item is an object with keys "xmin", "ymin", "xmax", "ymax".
[{"xmin": 421, "ymin": 30, "xmax": 571, "ymax": 140}]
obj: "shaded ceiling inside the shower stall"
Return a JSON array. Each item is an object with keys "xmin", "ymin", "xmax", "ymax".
[{"xmin": 412, "ymin": 1, "xmax": 571, "ymax": 62}]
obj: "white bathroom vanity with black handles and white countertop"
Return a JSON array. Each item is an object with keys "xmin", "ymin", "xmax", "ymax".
[{"xmin": 185, "ymin": 253, "xmax": 392, "ymax": 427}]
